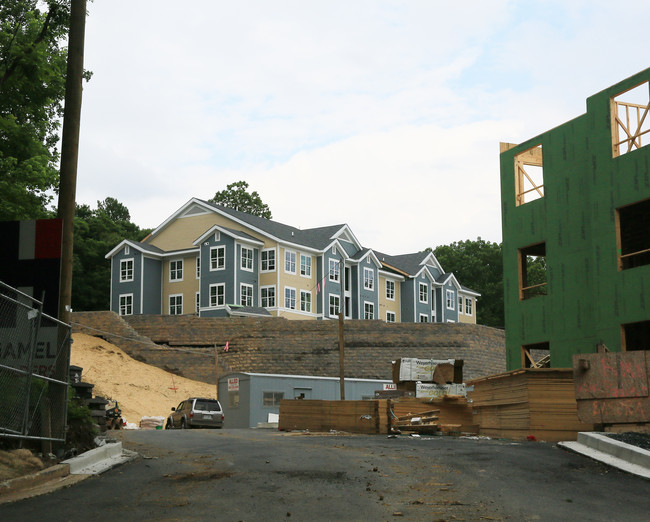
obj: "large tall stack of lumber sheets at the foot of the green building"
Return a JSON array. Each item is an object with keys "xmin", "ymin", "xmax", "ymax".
[{"xmin": 467, "ymin": 368, "xmax": 593, "ymax": 442}]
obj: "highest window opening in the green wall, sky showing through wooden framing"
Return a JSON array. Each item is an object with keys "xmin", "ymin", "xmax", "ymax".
[{"xmin": 610, "ymin": 82, "xmax": 650, "ymax": 158}]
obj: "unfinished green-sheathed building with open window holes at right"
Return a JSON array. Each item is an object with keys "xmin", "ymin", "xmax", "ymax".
[{"xmin": 500, "ymin": 69, "xmax": 650, "ymax": 370}]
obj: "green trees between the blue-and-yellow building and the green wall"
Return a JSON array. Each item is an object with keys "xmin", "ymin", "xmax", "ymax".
[{"xmin": 433, "ymin": 237, "xmax": 505, "ymax": 328}]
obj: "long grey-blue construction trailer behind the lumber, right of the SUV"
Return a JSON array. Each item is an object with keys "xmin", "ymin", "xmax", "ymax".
[{"xmin": 219, "ymin": 372, "xmax": 391, "ymax": 428}]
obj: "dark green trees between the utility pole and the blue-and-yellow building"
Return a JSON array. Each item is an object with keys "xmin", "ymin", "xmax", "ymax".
[{"xmin": 72, "ymin": 198, "xmax": 150, "ymax": 311}]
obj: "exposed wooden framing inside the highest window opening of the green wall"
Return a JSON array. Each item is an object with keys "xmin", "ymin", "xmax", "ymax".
[{"xmin": 610, "ymin": 82, "xmax": 650, "ymax": 158}]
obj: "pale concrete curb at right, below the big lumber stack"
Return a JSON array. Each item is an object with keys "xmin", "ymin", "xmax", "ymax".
[{"xmin": 558, "ymin": 432, "xmax": 650, "ymax": 479}]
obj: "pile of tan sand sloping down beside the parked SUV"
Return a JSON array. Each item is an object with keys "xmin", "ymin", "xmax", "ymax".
[{"xmin": 70, "ymin": 333, "xmax": 216, "ymax": 424}]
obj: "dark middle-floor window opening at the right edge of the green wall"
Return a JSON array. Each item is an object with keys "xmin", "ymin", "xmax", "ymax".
[{"xmin": 616, "ymin": 199, "xmax": 650, "ymax": 270}]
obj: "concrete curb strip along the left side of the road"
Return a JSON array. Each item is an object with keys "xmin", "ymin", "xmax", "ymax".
[{"xmin": 0, "ymin": 442, "xmax": 138, "ymax": 504}]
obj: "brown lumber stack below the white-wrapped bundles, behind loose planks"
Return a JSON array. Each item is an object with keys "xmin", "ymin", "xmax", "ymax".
[{"xmin": 390, "ymin": 397, "xmax": 479, "ymax": 434}]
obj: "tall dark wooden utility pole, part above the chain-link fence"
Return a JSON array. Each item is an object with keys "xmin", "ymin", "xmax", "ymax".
[{"xmin": 57, "ymin": 0, "xmax": 86, "ymax": 324}]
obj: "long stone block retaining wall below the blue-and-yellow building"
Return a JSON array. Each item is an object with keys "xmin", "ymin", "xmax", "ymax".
[{"xmin": 73, "ymin": 312, "xmax": 505, "ymax": 383}]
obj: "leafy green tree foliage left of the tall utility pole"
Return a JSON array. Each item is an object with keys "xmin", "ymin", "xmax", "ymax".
[{"xmin": 0, "ymin": 0, "xmax": 69, "ymax": 220}]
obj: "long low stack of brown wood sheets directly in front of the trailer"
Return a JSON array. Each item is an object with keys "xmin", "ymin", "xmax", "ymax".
[{"xmin": 278, "ymin": 399, "xmax": 389, "ymax": 434}]
